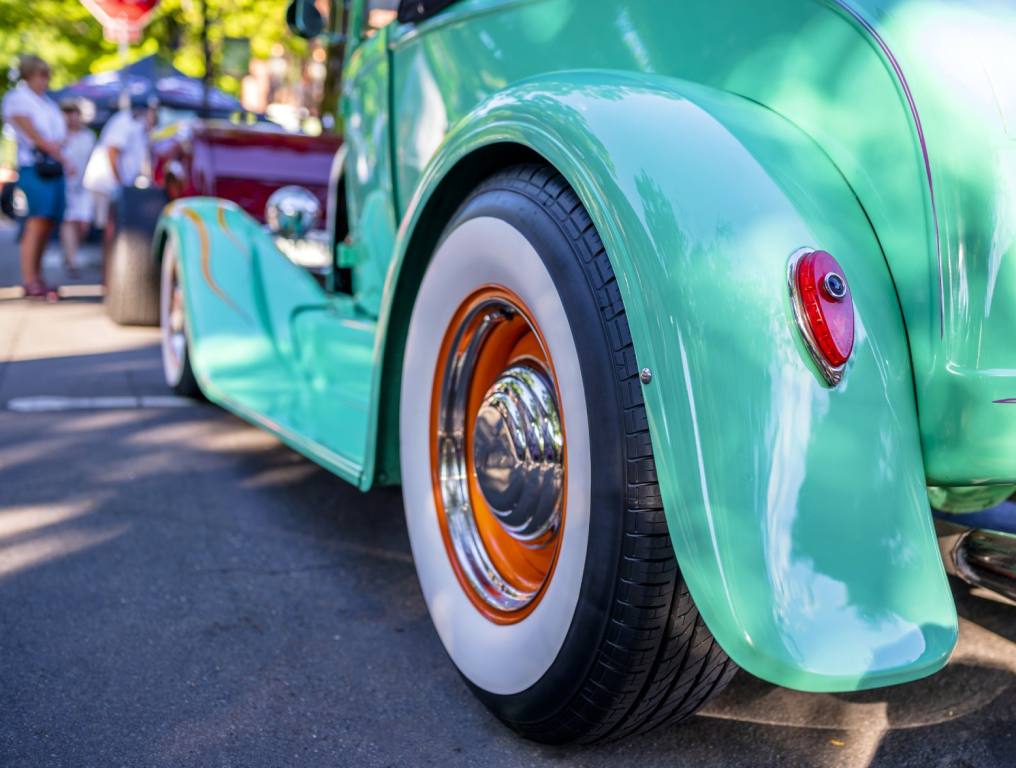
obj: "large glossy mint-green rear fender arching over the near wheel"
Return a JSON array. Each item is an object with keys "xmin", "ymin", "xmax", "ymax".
[{"xmin": 377, "ymin": 71, "xmax": 957, "ymax": 691}]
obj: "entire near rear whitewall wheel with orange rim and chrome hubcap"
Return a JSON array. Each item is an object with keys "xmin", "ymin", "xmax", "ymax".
[{"xmin": 399, "ymin": 165, "xmax": 736, "ymax": 743}]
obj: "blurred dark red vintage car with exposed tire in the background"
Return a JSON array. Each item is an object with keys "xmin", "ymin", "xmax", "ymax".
[{"xmin": 106, "ymin": 118, "xmax": 342, "ymax": 325}]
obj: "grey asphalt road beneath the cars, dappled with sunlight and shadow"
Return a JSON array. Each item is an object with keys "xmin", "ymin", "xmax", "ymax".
[{"xmin": 0, "ymin": 219, "xmax": 1016, "ymax": 768}]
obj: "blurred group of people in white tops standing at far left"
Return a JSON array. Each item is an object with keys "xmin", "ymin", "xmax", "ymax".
[{"xmin": 2, "ymin": 55, "xmax": 158, "ymax": 299}]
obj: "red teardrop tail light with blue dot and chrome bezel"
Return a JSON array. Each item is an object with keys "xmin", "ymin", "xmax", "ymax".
[{"xmin": 789, "ymin": 250, "xmax": 853, "ymax": 386}]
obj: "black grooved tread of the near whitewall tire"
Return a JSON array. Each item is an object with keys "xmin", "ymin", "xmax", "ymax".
[{"xmin": 477, "ymin": 164, "xmax": 737, "ymax": 743}]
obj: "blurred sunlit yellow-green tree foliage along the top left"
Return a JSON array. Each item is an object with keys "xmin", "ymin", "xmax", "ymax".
[{"xmin": 0, "ymin": 0, "xmax": 307, "ymax": 99}]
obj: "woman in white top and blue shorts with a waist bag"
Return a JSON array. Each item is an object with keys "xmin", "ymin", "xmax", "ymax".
[{"xmin": 3, "ymin": 56, "xmax": 67, "ymax": 299}]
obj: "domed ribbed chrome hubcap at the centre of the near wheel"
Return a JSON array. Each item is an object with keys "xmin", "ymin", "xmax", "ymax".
[{"xmin": 472, "ymin": 365, "xmax": 564, "ymax": 541}]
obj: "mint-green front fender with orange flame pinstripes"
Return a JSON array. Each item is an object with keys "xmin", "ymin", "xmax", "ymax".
[{"xmin": 152, "ymin": 197, "xmax": 327, "ymax": 438}]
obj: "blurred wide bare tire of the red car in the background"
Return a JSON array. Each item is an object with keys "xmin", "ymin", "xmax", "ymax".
[{"xmin": 106, "ymin": 188, "xmax": 167, "ymax": 325}]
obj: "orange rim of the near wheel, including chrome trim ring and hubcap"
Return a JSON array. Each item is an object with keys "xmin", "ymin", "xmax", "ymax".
[{"xmin": 431, "ymin": 285, "xmax": 567, "ymax": 624}]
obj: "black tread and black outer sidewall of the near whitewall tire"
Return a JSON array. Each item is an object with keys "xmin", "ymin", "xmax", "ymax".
[{"xmin": 403, "ymin": 165, "xmax": 737, "ymax": 743}]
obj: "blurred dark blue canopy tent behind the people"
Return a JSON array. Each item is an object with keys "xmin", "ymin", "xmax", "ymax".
[{"xmin": 52, "ymin": 56, "xmax": 243, "ymax": 124}]
